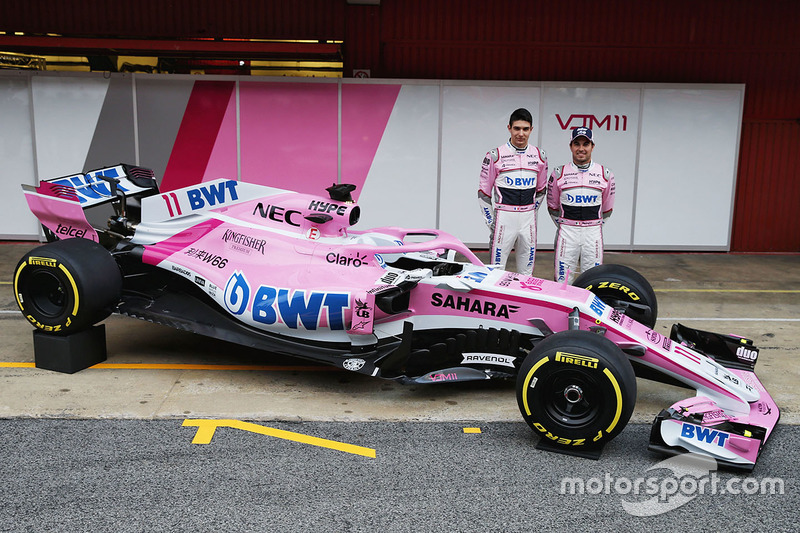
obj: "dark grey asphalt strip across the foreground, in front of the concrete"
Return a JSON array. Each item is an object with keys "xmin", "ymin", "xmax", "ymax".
[{"xmin": 0, "ymin": 419, "xmax": 800, "ymax": 533}]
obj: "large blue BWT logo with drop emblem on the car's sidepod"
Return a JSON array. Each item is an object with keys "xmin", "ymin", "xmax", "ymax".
[{"xmin": 224, "ymin": 270, "xmax": 350, "ymax": 330}]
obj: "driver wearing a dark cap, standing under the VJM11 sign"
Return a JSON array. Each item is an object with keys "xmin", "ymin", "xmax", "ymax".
[{"xmin": 547, "ymin": 128, "xmax": 616, "ymax": 283}]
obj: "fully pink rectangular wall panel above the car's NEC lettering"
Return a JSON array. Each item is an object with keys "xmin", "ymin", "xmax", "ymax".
[{"xmin": 239, "ymin": 82, "xmax": 338, "ymax": 193}]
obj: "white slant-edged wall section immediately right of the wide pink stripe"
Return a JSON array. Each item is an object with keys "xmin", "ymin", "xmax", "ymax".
[{"xmin": 356, "ymin": 84, "xmax": 439, "ymax": 230}]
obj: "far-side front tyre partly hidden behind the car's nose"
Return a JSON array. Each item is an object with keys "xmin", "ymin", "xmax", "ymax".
[{"xmin": 573, "ymin": 264, "xmax": 658, "ymax": 328}]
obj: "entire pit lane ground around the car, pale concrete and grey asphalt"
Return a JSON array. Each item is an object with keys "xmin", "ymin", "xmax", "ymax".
[{"xmin": 0, "ymin": 243, "xmax": 800, "ymax": 531}]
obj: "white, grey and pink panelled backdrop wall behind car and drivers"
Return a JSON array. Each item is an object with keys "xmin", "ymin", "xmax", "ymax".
[{"xmin": 0, "ymin": 71, "xmax": 744, "ymax": 251}]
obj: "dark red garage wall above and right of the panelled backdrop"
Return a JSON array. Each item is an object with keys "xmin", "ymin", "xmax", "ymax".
[{"xmin": 0, "ymin": 0, "xmax": 800, "ymax": 252}]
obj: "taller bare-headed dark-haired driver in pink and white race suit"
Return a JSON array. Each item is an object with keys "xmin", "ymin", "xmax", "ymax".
[{"xmin": 478, "ymin": 108, "xmax": 547, "ymax": 276}]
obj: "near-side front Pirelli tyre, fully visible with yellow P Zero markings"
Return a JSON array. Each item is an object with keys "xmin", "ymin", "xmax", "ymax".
[{"xmin": 517, "ymin": 330, "xmax": 636, "ymax": 446}]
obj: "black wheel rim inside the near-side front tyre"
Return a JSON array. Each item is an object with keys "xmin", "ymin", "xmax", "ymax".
[{"xmin": 543, "ymin": 368, "xmax": 602, "ymax": 428}]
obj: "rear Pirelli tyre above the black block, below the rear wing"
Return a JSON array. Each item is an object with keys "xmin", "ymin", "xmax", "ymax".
[{"xmin": 14, "ymin": 239, "xmax": 122, "ymax": 335}]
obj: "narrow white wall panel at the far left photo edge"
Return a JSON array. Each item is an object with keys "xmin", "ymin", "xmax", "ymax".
[{"xmin": 0, "ymin": 77, "xmax": 39, "ymax": 239}]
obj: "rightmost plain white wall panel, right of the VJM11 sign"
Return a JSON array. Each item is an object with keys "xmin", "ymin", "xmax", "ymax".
[{"xmin": 634, "ymin": 88, "xmax": 744, "ymax": 250}]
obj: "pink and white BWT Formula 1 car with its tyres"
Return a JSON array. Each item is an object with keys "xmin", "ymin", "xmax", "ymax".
[{"xmin": 14, "ymin": 165, "xmax": 779, "ymax": 469}]
